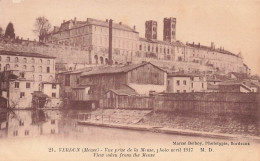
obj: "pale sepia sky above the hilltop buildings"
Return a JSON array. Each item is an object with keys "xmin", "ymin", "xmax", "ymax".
[{"xmin": 0, "ymin": 0, "xmax": 260, "ymax": 75}]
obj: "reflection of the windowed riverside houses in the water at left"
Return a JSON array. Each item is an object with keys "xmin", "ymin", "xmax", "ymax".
[{"xmin": 0, "ymin": 110, "xmax": 60, "ymax": 138}]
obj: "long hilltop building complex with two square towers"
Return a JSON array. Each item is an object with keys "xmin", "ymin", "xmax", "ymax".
[{"xmin": 46, "ymin": 17, "xmax": 250, "ymax": 74}]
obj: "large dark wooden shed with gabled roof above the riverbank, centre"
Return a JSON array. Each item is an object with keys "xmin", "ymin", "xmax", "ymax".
[{"xmin": 80, "ymin": 62, "xmax": 167, "ymax": 100}]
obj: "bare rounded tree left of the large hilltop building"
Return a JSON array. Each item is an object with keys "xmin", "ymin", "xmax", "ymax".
[{"xmin": 33, "ymin": 16, "xmax": 51, "ymax": 42}]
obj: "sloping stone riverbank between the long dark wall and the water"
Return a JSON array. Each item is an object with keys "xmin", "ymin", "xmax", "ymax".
[{"xmin": 78, "ymin": 109, "xmax": 260, "ymax": 141}]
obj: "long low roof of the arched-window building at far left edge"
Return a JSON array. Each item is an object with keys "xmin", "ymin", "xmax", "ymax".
[{"xmin": 0, "ymin": 50, "xmax": 55, "ymax": 59}]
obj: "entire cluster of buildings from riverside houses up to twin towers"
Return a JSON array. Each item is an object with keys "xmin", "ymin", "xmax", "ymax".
[{"xmin": 0, "ymin": 18, "xmax": 260, "ymax": 108}]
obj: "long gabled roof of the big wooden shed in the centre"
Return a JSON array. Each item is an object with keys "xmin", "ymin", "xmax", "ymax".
[{"xmin": 81, "ymin": 62, "xmax": 165, "ymax": 77}]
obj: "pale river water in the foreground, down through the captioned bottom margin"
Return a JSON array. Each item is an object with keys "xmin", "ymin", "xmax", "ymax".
[{"xmin": 0, "ymin": 110, "xmax": 260, "ymax": 161}]
